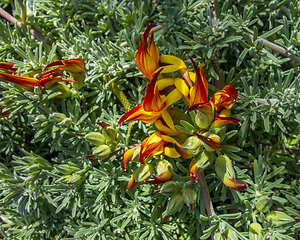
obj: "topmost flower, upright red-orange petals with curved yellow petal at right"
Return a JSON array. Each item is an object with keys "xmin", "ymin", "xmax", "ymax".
[{"xmin": 136, "ymin": 23, "xmax": 187, "ymax": 80}]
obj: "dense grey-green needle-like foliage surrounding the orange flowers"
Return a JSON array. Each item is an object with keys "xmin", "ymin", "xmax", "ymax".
[{"xmin": 0, "ymin": 0, "xmax": 300, "ymax": 240}]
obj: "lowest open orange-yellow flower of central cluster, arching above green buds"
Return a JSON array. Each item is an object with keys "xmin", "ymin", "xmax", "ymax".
[{"xmin": 139, "ymin": 132, "xmax": 192, "ymax": 164}]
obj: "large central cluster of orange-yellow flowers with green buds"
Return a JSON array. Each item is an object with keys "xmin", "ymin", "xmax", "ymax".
[{"xmin": 119, "ymin": 23, "xmax": 247, "ymax": 220}]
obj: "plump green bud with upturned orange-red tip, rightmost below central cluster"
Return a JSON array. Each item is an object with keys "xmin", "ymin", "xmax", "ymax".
[{"xmin": 215, "ymin": 155, "xmax": 248, "ymax": 191}]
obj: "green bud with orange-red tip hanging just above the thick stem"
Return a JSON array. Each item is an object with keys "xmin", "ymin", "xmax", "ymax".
[{"xmin": 189, "ymin": 150, "xmax": 214, "ymax": 182}]
